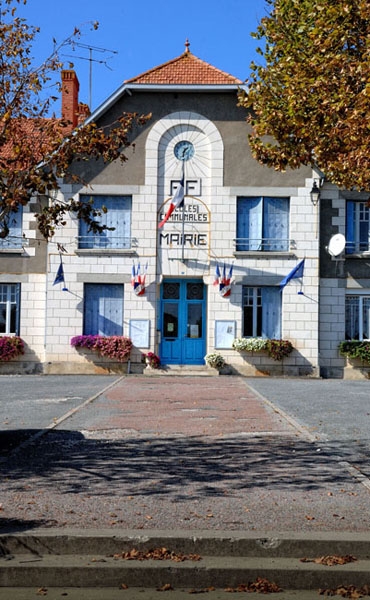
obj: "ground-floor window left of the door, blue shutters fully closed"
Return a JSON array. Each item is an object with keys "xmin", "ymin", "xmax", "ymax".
[{"xmin": 83, "ymin": 283, "xmax": 123, "ymax": 336}]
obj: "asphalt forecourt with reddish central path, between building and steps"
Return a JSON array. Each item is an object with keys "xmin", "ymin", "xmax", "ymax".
[{"xmin": 0, "ymin": 376, "xmax": 370, "ymax": 532}]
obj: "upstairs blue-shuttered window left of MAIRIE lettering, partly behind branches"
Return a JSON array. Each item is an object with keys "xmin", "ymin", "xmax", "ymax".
[{"xmin": 78, "ymin": 195, "xmax": 132, "ymax": 250}]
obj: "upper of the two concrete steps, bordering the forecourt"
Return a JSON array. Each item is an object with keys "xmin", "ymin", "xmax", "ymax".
[{"xmin": 0, "ymin": 528, "xmax": 370, "ymax": 560}]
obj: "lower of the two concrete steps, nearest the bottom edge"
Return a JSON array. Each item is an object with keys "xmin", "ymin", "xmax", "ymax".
[{"xmin": 0, "ymin": 554, "xmax": 370, "ymax": 590}]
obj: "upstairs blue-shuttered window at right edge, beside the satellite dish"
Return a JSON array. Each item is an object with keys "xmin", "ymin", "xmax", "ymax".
[{"xmin": 346, "ymin": 200, "xmax": 370, "ymax": 254}]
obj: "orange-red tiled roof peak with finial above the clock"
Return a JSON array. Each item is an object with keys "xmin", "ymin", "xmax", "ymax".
[{"xmin": 125, "ymin": 41, "xmax": 243, "ymax": 85}]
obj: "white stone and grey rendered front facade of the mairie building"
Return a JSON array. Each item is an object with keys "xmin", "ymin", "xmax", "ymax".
[{"xmin": 0, "ymin": 51, "xmax": 370, "ymax": 377}]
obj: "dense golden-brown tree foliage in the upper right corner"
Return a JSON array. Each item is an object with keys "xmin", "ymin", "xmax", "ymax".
[{"xmin": 240, "ymin": 0, "xmax": 370, "ymax": 190}]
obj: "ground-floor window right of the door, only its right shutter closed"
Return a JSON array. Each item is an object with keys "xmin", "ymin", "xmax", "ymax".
[{"xmin": 243, "ymin": 286, "xmax": 281, "ymax": 339}]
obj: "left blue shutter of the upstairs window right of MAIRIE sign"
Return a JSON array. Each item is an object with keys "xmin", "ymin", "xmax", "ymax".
[{"xmin": 237, "ymin": 198, "xmax": 262, "ymax": 251}]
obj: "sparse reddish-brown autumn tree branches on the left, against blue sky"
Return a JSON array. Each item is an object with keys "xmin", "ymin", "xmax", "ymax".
[{"xmin": 0, "ymin": 0, "xmax": 149, "ymax": 239}]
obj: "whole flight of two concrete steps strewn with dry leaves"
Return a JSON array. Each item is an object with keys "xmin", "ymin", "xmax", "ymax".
[{"xmin": 0, "ymin": 530, "xmax": 370, "ymax": 598}]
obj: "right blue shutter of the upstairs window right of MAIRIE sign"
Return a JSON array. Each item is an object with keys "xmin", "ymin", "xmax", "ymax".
[{"xmin": 262, "ymin": 198, "xmax": 289, "ymax": 251}]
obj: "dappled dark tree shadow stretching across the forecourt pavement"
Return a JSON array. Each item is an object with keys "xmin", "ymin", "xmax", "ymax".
[{"xmin": 0, "ymin": 430, "xmax": 362, "ymax": 501}]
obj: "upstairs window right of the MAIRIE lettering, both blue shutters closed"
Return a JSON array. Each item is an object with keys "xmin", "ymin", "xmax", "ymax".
[{"xmin": 236, "ymin": 197, "xmax": 289, "ymax": 252}]
